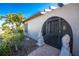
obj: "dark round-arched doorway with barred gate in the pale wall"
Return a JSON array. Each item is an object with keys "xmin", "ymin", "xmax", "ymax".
[{"xmin": 42, "ymin": 16, "xmax": 73, "ymax": 53}]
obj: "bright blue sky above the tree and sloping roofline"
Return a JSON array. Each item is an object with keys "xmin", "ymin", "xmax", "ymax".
[{"xmin": 0, "ymin": 3, "xmax": 57, "ymax": 24}]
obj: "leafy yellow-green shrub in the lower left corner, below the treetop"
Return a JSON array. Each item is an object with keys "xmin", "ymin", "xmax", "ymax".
[{"xmin": 0, "ymin": 30, "xmax": 24, "ymax": 56}]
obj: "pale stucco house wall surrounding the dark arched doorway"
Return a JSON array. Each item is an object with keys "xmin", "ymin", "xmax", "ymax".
[{"xmin": 28, "ymin": 4, "xmax": 79, "ymax": 55}]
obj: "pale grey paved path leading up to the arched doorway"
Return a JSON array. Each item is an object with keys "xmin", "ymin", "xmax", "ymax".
[{"xmin": 28, "ymin": 44, "xmax": 60, "ymax": 56}]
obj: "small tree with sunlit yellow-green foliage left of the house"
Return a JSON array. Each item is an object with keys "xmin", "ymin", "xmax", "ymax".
[{"xmin": 1, "ymin": 13, "xmax": 25, "ymax": 54}]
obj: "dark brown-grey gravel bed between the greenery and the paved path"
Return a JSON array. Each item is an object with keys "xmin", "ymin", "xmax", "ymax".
[{"xmin": 13, "ymin": 38, "xmax": 38, "ymax": 56}]
